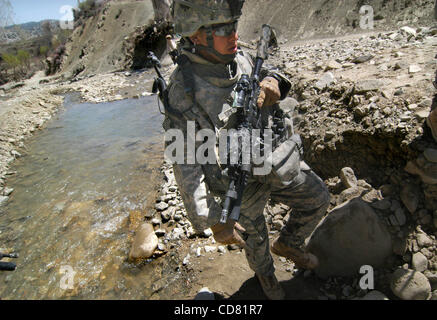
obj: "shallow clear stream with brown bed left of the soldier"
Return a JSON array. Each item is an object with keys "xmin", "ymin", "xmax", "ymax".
[{"xmin": 0, "ymin": 95, "xmax": 186, "ymax": 299}]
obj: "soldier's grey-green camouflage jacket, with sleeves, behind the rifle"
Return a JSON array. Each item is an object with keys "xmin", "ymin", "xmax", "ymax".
[{"xmin": 163, "ymin": 51, "xmax": 289, "ymax": 231}]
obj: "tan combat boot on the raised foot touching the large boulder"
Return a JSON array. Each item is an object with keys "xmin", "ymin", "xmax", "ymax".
[{"xmin": 270, "ymin": 238, "xmax": 319, "ymax": 270}]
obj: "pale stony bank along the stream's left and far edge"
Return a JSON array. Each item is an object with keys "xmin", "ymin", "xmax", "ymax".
[{"xmin": 0, "ymin": 61, "xmax": 176, "ymax": 203}]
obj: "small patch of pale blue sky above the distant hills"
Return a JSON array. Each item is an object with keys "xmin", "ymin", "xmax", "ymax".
[{"xmin": 9, "ymin": 0, "xmax": 77, "ymax": 24}]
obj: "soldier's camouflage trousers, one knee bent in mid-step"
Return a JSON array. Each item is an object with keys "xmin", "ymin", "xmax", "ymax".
[{"xmin": 239, "ymin": 164, "xmax": 329, "ymax": 275}]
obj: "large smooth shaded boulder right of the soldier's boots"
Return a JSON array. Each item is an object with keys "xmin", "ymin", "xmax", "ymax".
[{"xmin": 307, "ymin": 198, "xmax": 392, "ymax": 278}]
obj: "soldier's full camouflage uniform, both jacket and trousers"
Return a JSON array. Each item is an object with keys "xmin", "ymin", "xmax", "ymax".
[{"xmin": 163, "ymin": 51, "xmax": 329, "ymax": 275}]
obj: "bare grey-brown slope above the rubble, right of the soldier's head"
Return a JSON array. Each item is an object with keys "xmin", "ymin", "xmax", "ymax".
[{"xmin": 239, "ymin": 0, "xmax": 436, "ymax": 41}]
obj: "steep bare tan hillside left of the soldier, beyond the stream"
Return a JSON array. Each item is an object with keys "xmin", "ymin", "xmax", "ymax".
[{"xmin": 59, "ymin": 0, "xmax": 154, "ymax": 76}]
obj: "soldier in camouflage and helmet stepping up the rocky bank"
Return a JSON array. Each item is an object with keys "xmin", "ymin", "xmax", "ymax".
[{"xmin": 163, "ymin": 0, "xmax": 329, "ymax": 299}]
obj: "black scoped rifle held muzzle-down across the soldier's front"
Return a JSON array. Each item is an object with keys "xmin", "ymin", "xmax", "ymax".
[{"xmin": 220, "ymin": 24, "xmax": 272, "ymax": 224}]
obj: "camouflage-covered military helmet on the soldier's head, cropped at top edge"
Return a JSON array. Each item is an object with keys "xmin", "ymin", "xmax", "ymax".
[{"xmin": 172, "ymin": 0, "xmax": 245, "ymax": 37}]
